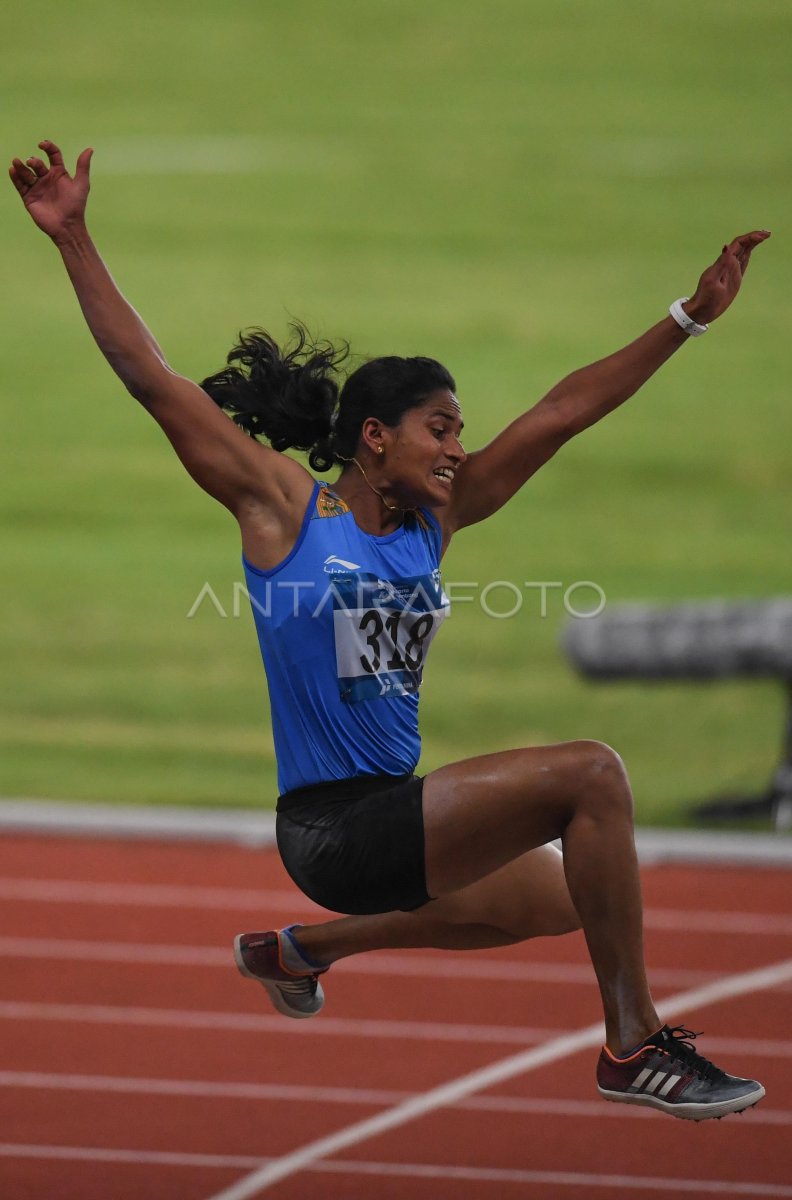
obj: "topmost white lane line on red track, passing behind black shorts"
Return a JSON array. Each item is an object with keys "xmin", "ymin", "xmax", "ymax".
[{"xmin": 0, "ymin": 876, "xmax": 792, "ymax": 935}]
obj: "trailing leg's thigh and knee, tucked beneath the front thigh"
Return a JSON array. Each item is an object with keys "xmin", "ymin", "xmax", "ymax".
[{"xmin": 421, "ymin": 846, "xmax": 580, "ymax": 942}]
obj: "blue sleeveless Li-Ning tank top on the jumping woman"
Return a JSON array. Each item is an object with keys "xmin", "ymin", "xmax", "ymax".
[{"xmin": 242, "ymin": 484, "xmax": 449, "ymax": 793}]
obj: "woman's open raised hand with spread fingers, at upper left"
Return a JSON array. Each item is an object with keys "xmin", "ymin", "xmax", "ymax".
[{"xmin": 8, "ymin": 139, "xmax": 94, "ymax": 240}]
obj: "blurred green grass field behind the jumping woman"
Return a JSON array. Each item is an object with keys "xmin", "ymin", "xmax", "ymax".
[{"xmin": 0, "ymin": 0, "xmax": 792, "ymax": 823}]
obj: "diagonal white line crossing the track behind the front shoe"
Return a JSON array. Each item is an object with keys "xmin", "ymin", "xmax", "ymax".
[{"xmin": 202, "ymin": 959, "xmax": 792, "ymax": 1200}]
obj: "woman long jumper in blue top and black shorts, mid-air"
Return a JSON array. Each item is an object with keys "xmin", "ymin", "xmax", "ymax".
[{"xmin": 10, "ymin": 142, "xmax": 769, "ymax": 1121}]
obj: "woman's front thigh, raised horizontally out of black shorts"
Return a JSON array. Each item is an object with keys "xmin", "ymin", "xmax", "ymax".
[{"xmin": 424, "ymin": 742, "xmax": 626, "ymax": 896}]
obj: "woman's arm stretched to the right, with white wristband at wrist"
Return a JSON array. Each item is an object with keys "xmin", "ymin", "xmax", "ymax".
[{"xmin": 445, "ymin": 229, "xmax": 770, "ymax": 532}]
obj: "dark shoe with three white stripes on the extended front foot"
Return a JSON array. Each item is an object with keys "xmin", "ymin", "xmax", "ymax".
[{"xmin": 596, "ymin": 1025, "xmax": 764, "ymax": 1121}]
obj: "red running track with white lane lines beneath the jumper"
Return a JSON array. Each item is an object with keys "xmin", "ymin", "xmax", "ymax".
[{"xmin": 0, "ymin": 836, "xmax": 792, "ymax": 1200}]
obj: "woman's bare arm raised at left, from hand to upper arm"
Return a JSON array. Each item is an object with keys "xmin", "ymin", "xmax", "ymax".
[{"xmin": 8, "ymin": 140, "xmax": 312, "ymax": 516}]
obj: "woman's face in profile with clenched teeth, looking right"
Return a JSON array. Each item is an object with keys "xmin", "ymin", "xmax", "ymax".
[{"xmin": 383, "ymin": 389, "xmax": 467, "ymax": 508}]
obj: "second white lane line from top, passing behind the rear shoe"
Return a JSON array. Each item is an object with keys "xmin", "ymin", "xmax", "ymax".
[{"xmin": 0, "ymin": 937, "xmax": 719, "ymax": 988}]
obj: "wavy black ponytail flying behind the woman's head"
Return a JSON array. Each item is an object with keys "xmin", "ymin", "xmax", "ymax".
[{"xmin": 200, "ymin": 322, "xmax": 349, "ymax": 458}]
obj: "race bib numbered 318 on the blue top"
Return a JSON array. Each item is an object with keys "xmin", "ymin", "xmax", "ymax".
[{"xmin": 332, "ymin": 571, "xmax": 450, "ymax": 704}]
